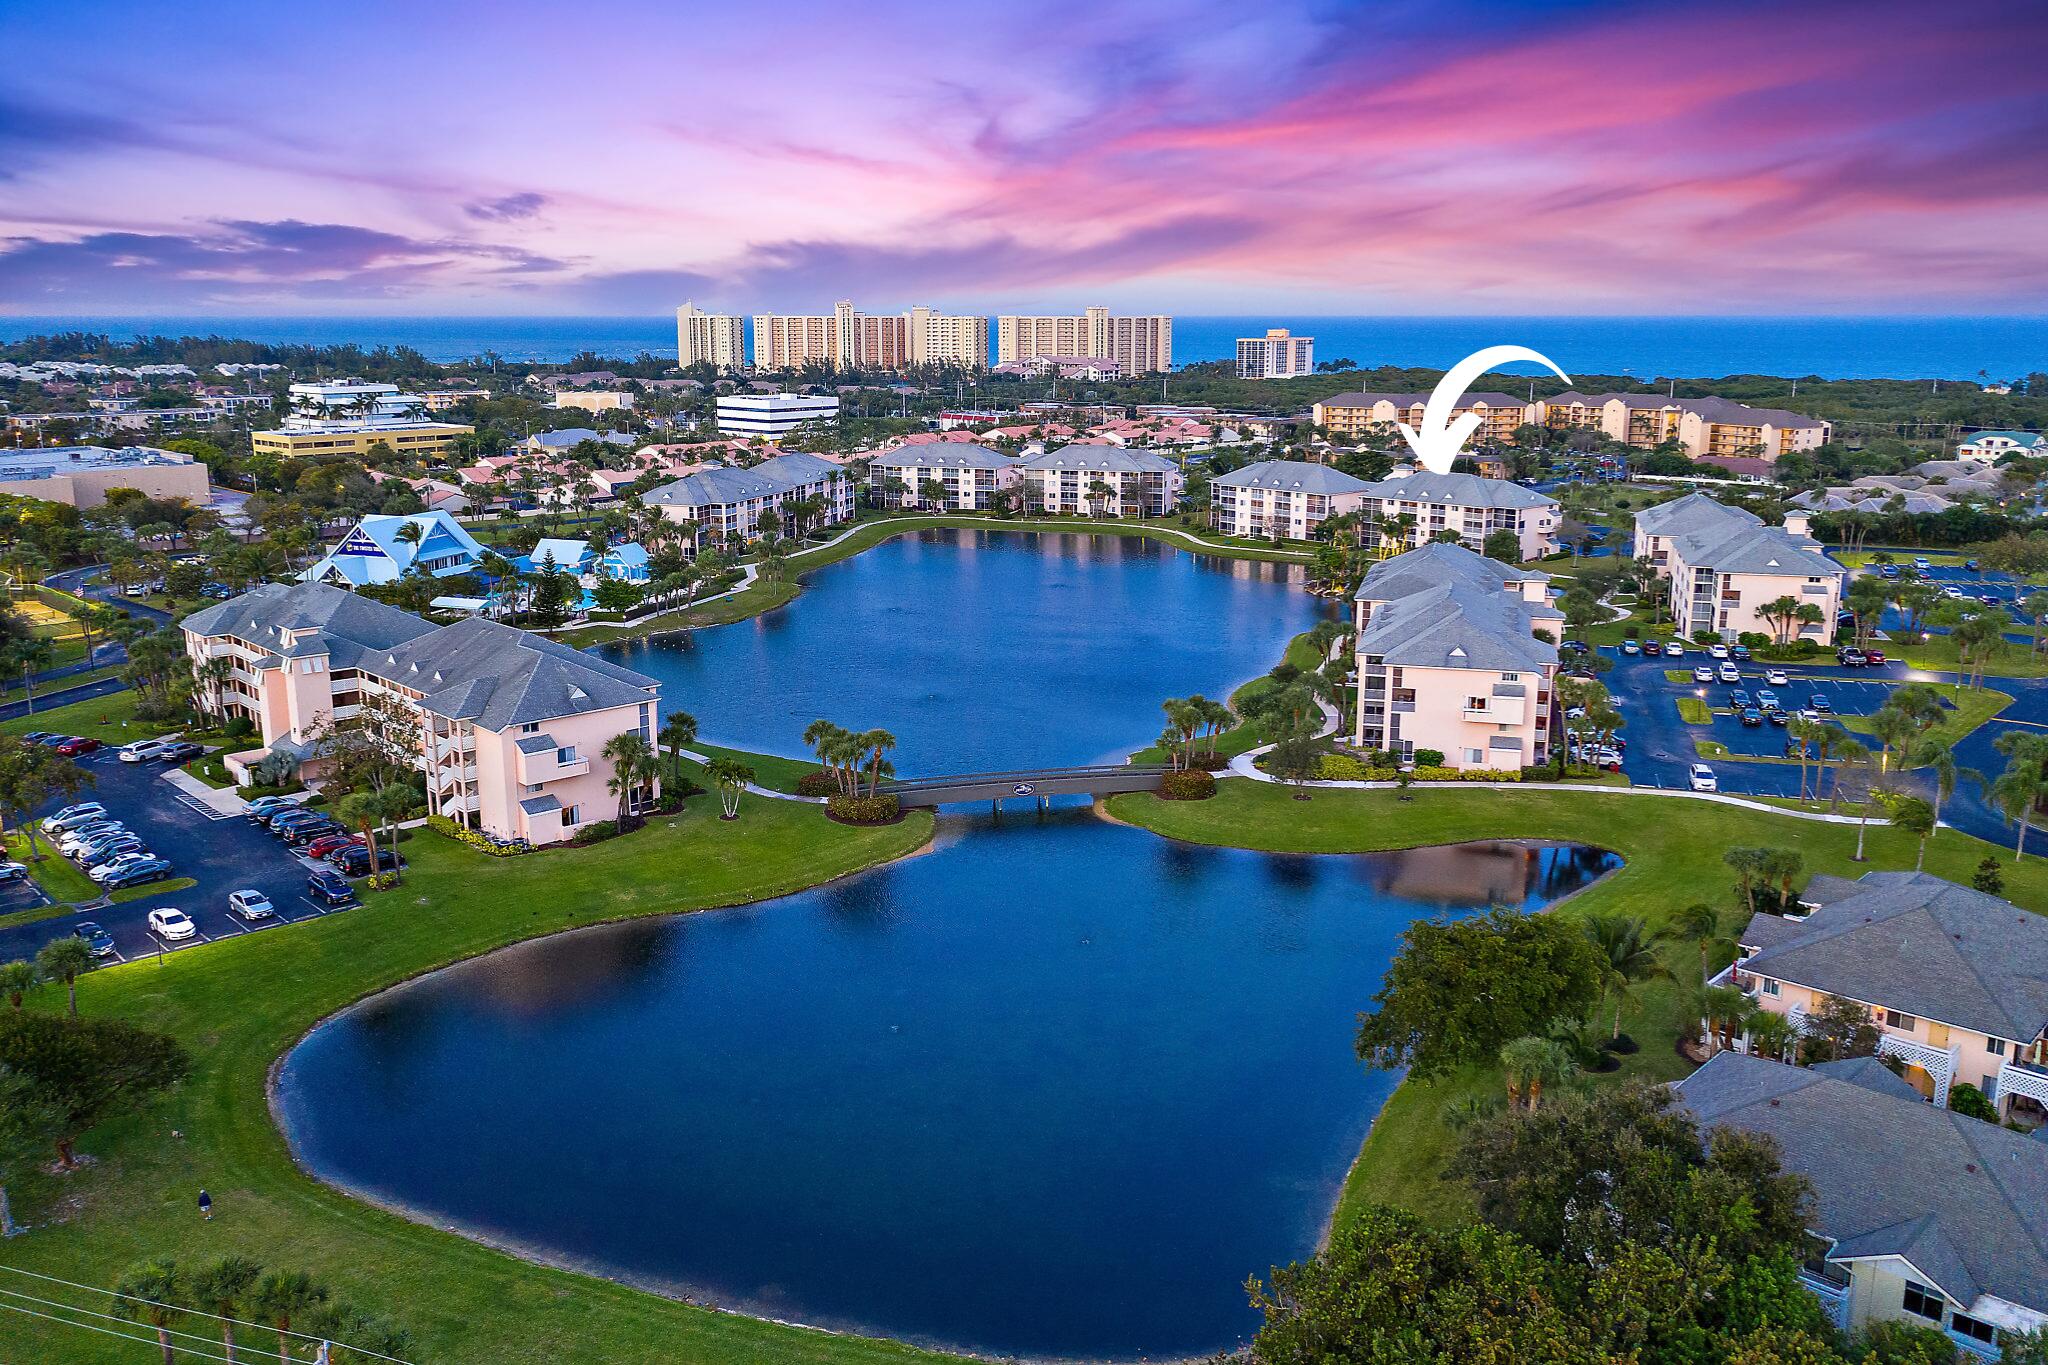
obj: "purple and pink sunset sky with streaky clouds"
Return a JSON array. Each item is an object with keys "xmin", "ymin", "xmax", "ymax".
[{"xmin": 0, "ymin": 0, "xmax": 2048, "ymax": 313}]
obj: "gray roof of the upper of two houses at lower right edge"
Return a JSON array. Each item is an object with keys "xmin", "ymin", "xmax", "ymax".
[{"xmin": 1743, "ymin": 872, "xmax": 2048, "ymax": 1042}]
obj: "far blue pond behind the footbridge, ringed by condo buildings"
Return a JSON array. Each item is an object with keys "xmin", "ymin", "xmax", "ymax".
[{"xmin": 598, "ymin": 530, "xmax": 1329, "ymax": 776}]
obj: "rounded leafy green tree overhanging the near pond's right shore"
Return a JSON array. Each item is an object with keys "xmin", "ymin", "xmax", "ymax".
[{"xmin": 1358, "ymin": 907, "xmax": 1606, "ymax": 1078}]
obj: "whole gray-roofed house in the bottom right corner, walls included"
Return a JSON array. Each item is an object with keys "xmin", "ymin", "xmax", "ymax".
[{"xmin": 1673, "ymin": 1047, "xmax": 2048, "ymax": 1361}]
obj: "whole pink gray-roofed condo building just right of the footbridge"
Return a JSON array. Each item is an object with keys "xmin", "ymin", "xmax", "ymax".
[{"xmin": 1352, "ymin": 542, "xmax": 1565, "ymax": 769}]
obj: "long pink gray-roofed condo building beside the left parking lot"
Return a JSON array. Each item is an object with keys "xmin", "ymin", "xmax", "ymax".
[{"xmin": 182, "ymin": 583, "xmax": 659, "ymax": 843}]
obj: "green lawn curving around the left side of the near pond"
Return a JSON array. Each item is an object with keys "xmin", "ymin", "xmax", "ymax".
[{"xmin": 0, "ymin": 796, "xmax": 932, "ymax": 1365}]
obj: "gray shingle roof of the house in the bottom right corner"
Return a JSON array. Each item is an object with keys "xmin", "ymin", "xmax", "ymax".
[{"xmin": 1677, "ymin": 1052, "xmax": 2048, "ymax": 1312}]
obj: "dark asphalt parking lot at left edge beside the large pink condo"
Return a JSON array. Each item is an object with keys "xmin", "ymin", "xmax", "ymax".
[{"xmin": 0, "ymin": 749, "xmax": 362, "ymax": 962}]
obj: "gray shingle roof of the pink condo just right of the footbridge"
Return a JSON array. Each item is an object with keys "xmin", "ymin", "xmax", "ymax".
[{"xmin": 1356, "ymin": 544, "xmax": 1559, "ymax": 671}]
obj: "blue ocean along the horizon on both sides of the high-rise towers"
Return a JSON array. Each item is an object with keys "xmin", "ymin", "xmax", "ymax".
[{"xmin": 0, "ymin": 315, "xmax": 2048, "ymax": 381}]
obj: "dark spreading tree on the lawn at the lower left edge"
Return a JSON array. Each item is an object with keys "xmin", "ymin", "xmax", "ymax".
[{"xmin": 0, "ymin": 1011, "xmax": 193, "ymax": 1169}]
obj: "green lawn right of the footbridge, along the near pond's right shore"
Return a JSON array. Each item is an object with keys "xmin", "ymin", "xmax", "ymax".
[{"xmin": 1108, "ymin": 778, "xmax": 2048, "ymax": 1222}]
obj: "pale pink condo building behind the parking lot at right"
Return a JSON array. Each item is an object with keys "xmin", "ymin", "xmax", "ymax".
[{"xmin": 1634, "ymin": 493, "xmax": 1843, "ymax": 645}]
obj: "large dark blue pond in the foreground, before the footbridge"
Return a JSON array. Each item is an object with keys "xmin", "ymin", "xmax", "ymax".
[{"xmin": 276, "ymin": 806, "xmax": 1618, "ymax": 1359}]
